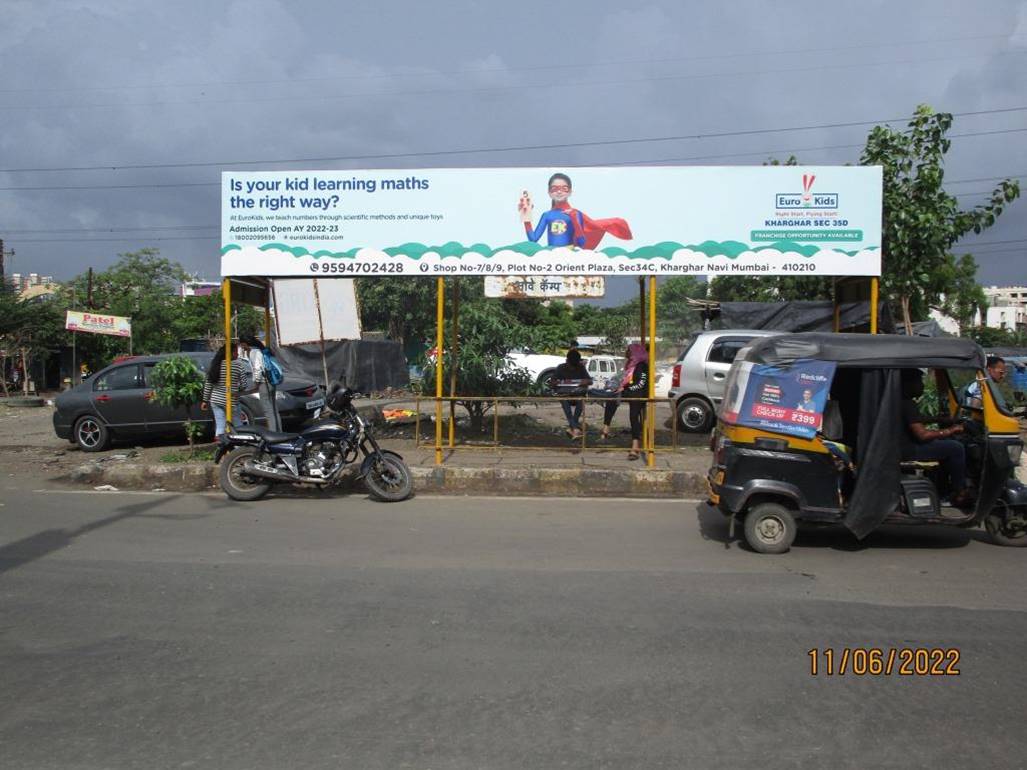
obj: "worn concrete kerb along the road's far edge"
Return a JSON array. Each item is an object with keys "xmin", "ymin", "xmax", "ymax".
[{"xmin": 65, "ymin": 463, "xmax": 706, "ymax": 498}]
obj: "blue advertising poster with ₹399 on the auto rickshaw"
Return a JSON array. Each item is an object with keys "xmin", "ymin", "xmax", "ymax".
[{"xmin": 721, "ymin": 359, "xmax": 835, "ymax": 438}]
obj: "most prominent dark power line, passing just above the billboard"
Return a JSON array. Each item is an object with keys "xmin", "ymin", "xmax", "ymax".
[{"xmin": 0, "ymin": 107, "xmax": 1027, "ymax": 174}]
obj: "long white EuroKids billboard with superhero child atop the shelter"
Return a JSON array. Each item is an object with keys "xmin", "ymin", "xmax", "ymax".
[{"xmin": 221, "ymin": 166, "xmax": 881, "ymax": 277}]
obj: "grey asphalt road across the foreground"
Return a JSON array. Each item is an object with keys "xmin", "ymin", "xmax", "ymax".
[{"xmin": 0, "ymin": 473, "xmax": 1027, "ymax": 770}]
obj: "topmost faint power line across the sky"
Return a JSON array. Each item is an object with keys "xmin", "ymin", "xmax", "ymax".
[{"xmin": 0, "ymin": 33, "xmax": 1024, "ymax": 93}]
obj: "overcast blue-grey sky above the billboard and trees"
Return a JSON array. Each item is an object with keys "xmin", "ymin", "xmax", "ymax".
[{"xmin": 0, "ymin": 0, "xmax": 1027, "ymax": 305}]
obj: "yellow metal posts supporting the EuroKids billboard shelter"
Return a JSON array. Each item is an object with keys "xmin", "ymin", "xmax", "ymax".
[{"xmin": 221, "ymin": 275, "xmax": 880, "ymax": 474}]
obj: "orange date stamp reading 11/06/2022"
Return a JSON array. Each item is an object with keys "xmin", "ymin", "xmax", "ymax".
[{"xmin": 806, "ymin": 647, "xmax": 960, "ymax": 677}]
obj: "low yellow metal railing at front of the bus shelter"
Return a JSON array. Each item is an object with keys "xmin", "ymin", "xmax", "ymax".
[{"xmin": 414, "ymin": 395, "xmax": 679, "ymax": 465}]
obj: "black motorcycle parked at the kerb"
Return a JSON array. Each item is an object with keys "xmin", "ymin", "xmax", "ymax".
[{"xmin": 214, "ymin": 384, "xmax": 414, "ymax": 502}]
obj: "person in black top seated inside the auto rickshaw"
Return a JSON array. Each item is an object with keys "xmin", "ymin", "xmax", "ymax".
[{"xmin": 901, "ymin": 370, "xmax": 973, "ymax": 507}]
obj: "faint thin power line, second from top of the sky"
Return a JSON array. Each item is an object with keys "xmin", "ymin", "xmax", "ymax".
[{"xmin": 8, "ymin": 49, "xmax": 1027, "ymax": 112}]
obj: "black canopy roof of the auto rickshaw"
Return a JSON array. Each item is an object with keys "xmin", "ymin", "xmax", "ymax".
[{"xmin": 746, "ymin": 333, "xmax": 985, "ymax": 369}]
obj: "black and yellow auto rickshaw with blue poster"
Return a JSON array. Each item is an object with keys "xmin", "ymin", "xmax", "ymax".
[{"xmin": 707, "ymin": 334, "xmax": 1027, "ymax": 553}]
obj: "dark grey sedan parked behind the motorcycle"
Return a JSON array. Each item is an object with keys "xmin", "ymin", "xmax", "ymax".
[{"xmin": 53, "ymin": 353, "xmax": 325, "ymax": 452}]
